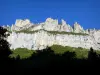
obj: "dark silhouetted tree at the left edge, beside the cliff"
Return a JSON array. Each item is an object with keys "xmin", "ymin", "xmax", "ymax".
[{"xmin": 0, "ymin": 27, "xmax": 11, "ymax": 58}]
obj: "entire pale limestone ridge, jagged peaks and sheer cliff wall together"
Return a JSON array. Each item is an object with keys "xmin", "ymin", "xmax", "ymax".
[{"xmin": 3, "ymin": 18, "xmax": 100, "ymax": 50}]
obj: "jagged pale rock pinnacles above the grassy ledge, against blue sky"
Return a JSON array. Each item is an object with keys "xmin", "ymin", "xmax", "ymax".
[{"xmin": 2, "ymin": 18, "xmax": 88, "ymax": 33}]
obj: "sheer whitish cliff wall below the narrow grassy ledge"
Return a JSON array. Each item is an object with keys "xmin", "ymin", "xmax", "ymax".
[{"xmin": 7, "ymin": 30, "xmax": 100, "ymax": 50}]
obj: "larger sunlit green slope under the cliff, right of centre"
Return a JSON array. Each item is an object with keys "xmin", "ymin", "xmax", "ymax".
[{"xmin": 51, "ymin": 45, "xmax": 88, "ymax": 58}]
